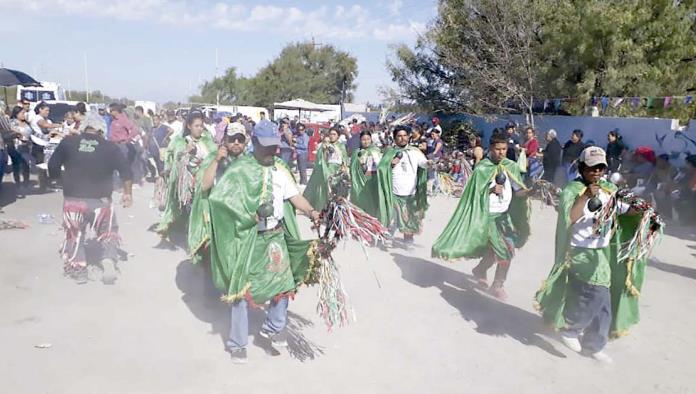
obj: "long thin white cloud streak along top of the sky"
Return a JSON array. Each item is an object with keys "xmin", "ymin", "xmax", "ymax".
[{"xmin": 0, "ymin": 0, "xmax": 425, "ymax": 41}]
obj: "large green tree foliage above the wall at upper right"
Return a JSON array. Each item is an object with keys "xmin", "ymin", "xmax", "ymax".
[{"xmin": 387, "ymin": 0, "xmax": 696, "ymax": 118}]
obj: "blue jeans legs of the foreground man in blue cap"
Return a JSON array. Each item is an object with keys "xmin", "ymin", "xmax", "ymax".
[{"xmin": 226, "ymin": 297, "xmax": 288, "ymax": 349}]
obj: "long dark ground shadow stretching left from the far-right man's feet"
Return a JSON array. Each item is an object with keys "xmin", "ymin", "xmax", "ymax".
[{"xmin": 392, "ymin": 253, "xmax": 566, "ymax": 358}]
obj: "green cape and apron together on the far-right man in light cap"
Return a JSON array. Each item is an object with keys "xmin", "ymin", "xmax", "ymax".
[{"xmin": 535, "ymin": 180, "xmax": 647, "ymax": 337}]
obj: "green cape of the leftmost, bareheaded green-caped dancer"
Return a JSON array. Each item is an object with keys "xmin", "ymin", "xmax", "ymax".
[{"xmin": 156, "ymin": 131, "xmax": 217, "ymax": 237}]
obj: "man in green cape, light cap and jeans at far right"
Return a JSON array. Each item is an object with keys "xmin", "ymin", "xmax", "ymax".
[{"xmin": 536, "ymin": 147, "xmax": 646, "ymax": 362}]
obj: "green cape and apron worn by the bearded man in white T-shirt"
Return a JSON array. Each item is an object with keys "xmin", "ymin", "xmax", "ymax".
[{"xmin": 377, "ymin": 146, "xmax": 428, "ymax": 234}]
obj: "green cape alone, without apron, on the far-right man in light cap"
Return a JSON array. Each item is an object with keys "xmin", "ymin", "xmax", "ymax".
[{"xmin": 535, "ymin": 180, "xmax": 647, "ymax": 337}]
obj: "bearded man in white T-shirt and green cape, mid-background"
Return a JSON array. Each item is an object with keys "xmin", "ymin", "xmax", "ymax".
[{"xmin": 377, "ymin": 126, "xmax": 430, "ymax": 245}]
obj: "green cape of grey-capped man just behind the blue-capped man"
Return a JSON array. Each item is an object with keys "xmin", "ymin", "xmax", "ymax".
[{"xmin": 188, "ymin": 152, "xmax": 244, "ymax": 264}]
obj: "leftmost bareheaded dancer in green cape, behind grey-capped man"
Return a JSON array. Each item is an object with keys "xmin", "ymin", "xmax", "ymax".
[{"xmin": 156, "ymin": 110, "xmax": 216, "ymax": 238}]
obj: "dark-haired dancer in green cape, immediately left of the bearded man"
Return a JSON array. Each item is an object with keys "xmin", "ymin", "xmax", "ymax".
[{"xmin": 350, "ymin": 131, "xmax": 382, "ymax": 216}]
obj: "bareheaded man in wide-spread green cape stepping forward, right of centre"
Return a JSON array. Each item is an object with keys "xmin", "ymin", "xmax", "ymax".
[{"xmin": 432, "ymin": 133, "xmax": 529, "ymax": 300}]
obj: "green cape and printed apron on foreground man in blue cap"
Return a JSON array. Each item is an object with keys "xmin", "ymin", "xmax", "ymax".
[{"xmin": 208, "ymin": 156, "xmax": 319, "ymax": 305}]
